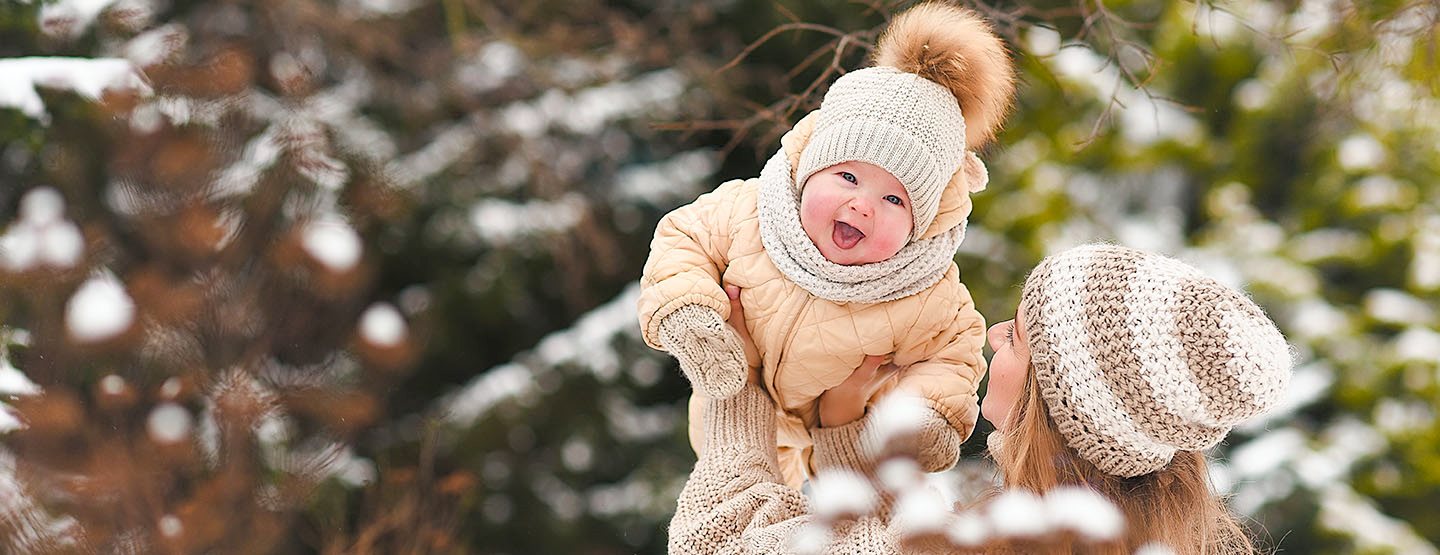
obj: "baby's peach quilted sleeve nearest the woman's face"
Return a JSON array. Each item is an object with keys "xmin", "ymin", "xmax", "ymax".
[{"xmin": 897, "ymin": 278, "xmax": 985, "ymax": 440}]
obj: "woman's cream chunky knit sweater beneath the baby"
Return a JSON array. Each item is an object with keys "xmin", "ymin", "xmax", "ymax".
[{"xmin": 670, "ymin": 383, "xmax": 900, "ymax": 554}]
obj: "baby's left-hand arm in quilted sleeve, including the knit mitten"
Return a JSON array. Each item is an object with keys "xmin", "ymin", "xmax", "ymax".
[{"xmin": 638, "ymin": 182, "xmax": 746, "ymax": 398}]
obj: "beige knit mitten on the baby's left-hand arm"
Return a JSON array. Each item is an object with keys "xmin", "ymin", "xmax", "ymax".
[{"xmin": 660, "ymin": 304, "xmax": 749, "ymax": 399}]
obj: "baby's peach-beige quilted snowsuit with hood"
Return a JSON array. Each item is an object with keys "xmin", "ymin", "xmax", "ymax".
[{"xmin": 638, "ymin": 118, "xmax": 985, "ymax": 487}]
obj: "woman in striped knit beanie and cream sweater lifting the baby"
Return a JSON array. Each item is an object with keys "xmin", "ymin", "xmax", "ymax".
[{"xmin": 670, "ymin": 245, "xmax": 1290, "ymax": 554}]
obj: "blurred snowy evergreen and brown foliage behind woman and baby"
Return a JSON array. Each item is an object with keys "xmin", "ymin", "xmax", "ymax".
[{"xmin": 0, "ymin": 0, "xmax": 1440, "ymax": 554}]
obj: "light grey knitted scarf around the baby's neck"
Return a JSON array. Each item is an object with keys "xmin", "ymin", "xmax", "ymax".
[{"xmin": 759, "ymin": 148, "xmax": 965, "ymax": 303}]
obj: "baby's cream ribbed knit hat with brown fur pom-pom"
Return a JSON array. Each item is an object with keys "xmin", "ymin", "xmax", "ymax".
[{"xmin": 795, "ymin": 3, "xmax": 1015, "ymax": 239}]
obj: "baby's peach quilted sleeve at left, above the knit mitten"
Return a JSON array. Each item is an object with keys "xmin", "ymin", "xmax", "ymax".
[{"xmin": 638, "ymin": 180, "xmax": 744, "ymax": 349}]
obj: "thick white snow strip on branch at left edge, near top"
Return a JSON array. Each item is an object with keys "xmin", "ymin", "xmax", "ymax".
[{"xmin": 0, "ymin": 56, "xmax": 153, "ymax": 124}]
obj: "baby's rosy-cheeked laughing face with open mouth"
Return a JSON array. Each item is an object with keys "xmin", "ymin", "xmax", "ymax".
[{"xmin": 801, "ymin": 161, "xmax": 914, "ymax": 265}]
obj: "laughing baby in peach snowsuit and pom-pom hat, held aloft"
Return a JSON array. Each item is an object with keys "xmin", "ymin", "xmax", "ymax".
[{"xmin": 639, "ymin": 4, "xmax": 1015, "ymax": 487}]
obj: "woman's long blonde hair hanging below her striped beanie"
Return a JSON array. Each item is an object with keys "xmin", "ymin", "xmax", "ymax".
[{"xmin": 991, "ymin": 369, "xmax": 1256, "ymax": 555}]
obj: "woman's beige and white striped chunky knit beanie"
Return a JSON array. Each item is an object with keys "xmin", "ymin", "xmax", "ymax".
[{"xmin": 1021, "ymin": 245, "xmax": 1292, "ymax": 477}]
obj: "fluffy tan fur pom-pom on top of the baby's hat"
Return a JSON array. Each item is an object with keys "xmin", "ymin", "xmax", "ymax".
[{"xmin": 876, "ymin": 1, "xmax": 1015, "ymax": 148}]
